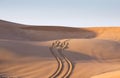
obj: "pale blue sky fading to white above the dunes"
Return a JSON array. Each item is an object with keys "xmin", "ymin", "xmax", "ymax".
[{"xmin": 0, "ymin": 0, "xmax": 120, "ymax": 27}]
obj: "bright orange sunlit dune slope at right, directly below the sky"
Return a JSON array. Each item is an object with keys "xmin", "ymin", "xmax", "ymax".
[{"xmin": 88, "ymin": 27, "xmax": 120, "ymax": 41}]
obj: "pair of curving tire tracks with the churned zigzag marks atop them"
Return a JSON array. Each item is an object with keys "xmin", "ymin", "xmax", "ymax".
[{"xmin": 49, "ymin": 41, "xmax": 74, "ymax": 78}]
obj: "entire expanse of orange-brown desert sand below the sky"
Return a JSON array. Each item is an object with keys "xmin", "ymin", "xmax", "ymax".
[{"xmin": 0, "ymin": 20, "xmax": 120, "ymax": 78}]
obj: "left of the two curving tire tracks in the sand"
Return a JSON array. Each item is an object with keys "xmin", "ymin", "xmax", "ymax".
[{"xmin": 49, "ymin": 47, "xmax": 64, "ymax": 78}]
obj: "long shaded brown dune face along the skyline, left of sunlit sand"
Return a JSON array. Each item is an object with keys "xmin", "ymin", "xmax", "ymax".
[{"xmin": 0, "ymin": 21, "xmax": 96, "ymax": 41}]
